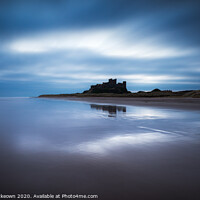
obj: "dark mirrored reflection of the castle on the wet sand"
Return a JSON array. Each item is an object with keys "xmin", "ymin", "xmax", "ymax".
[{"xmin": 90, "ymin": 104, "xmax": 126, "ymax": 117}]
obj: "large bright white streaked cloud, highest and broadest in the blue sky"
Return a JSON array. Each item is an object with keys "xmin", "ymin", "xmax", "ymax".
[{"xmin": 7, "ymin": 26, "xmax": 195, "ymax": 59}]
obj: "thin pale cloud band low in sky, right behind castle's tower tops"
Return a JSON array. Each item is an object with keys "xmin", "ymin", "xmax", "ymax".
[{"xmin": 0, "ymin": 67, "xmax": 199, "ymax": 84}]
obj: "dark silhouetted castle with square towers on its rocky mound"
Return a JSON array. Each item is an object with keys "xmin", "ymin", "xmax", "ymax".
[{"xmin": 83, "ymin": 79, "xmax": 129, "ymax": 94}]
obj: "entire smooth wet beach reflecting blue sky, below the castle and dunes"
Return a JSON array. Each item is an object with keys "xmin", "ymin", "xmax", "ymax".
[{"xmin": 0, "ymin": 98, "xmax": 200, "ymax": 200}]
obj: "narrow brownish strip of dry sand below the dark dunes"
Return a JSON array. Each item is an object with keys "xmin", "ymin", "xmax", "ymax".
[{"xmin": 39, "ymin": 96, "xmax": 200, "ymax": 111}]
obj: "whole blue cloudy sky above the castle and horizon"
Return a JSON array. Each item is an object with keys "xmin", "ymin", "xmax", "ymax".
[{"xmin": 0, "ymin": 0, "xmax": 200, "ymax": 97}]
